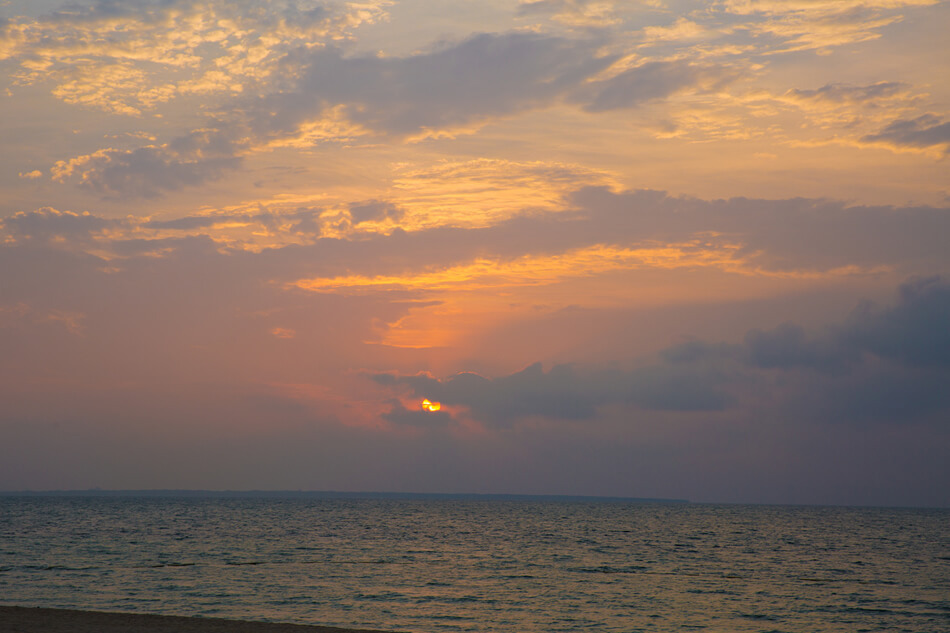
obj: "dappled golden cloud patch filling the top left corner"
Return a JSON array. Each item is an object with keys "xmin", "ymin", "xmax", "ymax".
[{"xmin": 0, "ymin": 0, "xmax": 386, "ymax": 116}]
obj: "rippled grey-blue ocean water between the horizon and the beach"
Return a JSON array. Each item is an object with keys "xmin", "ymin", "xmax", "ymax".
[{"xmin": 0, "ymin": 497, "xmax": 950, "ymax": 633}]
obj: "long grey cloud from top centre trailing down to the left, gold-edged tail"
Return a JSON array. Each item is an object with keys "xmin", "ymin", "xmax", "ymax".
[{"xmin": 53, "ymin": 32, "xmax": 616, "ymax": 196}]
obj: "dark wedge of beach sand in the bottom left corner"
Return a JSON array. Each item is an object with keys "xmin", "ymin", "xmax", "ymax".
[{"xmin": 0, "ymin": 606, "xmax": 406, "ymax": 633}]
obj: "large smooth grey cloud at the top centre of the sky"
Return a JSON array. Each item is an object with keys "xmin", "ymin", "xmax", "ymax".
[{"xmin": 292, "ymin": 32, "xmax": 616, "ymax": 136}]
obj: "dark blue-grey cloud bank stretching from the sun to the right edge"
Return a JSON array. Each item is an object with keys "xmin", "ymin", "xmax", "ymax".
[{"xmin": 368, "ymin": 278, "xmax": 950, "ymax": 428}]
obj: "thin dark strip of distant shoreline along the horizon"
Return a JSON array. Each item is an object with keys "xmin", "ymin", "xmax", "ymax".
[{"xmin": 0, "ymin": 488, "xmax": 689, "ymax": 504}]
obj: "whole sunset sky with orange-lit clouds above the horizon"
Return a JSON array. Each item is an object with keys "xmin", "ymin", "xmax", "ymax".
[{"xmin": 0, "ymin": 0, "xmax": 950, "ymax": 506}]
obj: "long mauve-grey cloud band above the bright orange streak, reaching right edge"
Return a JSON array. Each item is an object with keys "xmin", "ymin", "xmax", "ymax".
[{"xmin": 268, "ymin": 187, "xmax": 950, "ymax": 275}]
